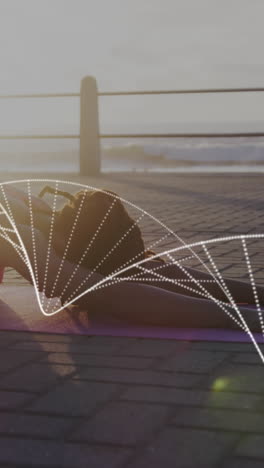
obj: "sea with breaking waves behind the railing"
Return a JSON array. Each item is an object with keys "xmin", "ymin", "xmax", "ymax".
[{"xmin": 0, "ymin": 138, "xmax": 264, "ymax": 174}]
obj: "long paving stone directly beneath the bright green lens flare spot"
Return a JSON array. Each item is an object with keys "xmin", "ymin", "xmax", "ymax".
[{"xmin": 120, "ymin": 386, "xmax": 262, "ymax": 409}]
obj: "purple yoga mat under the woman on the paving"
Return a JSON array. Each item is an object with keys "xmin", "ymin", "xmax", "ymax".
[{"xmin": 0, "ymin": 285, "xmax": 264, "ymax": 343}]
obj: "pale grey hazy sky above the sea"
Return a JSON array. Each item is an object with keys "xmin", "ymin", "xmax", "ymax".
[{"xmin": 0, "ymin": 0, "xmax": 264, "ymax": 138}]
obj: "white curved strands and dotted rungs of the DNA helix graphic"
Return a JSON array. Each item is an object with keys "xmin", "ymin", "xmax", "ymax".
[{"xmin": 0, "ymin": 179, "xmax": 264, "ymax": 362}]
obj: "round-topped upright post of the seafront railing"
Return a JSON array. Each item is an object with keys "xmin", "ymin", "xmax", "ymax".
[{"xmin": 80, "ymin": 76, "xmax": 101, "ymax": 176}]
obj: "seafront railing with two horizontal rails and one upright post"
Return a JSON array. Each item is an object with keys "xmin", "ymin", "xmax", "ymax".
[{"xmin": 0, "ymin": 76, "xmax": 264, "ymax": 175}]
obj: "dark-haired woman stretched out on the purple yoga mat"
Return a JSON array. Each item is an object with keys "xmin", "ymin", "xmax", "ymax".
[{"xmin": 0, "ymin": 185, "xmax": 264, "ymax": 331}]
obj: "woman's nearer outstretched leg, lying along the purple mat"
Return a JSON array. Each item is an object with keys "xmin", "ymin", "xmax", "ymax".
[{"xmin": 77, "ymin": 282, "xmax": 261, "ymax": 331}]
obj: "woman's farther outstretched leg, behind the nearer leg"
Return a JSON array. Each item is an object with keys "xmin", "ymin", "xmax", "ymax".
[{"xmin": 134, "ymin": 261, "xmax": 264, "ymax": 304}]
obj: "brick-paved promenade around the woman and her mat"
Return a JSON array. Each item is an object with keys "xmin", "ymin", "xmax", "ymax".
[{"xmin": 0, "ymin": 174, "xmax": 264, "ymax": 468}]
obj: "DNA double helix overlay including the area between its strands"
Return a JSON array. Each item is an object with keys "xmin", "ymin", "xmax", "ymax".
[{"xmin": 0, "ymin": 179, "xmax": 264, "ymax": 362}]
